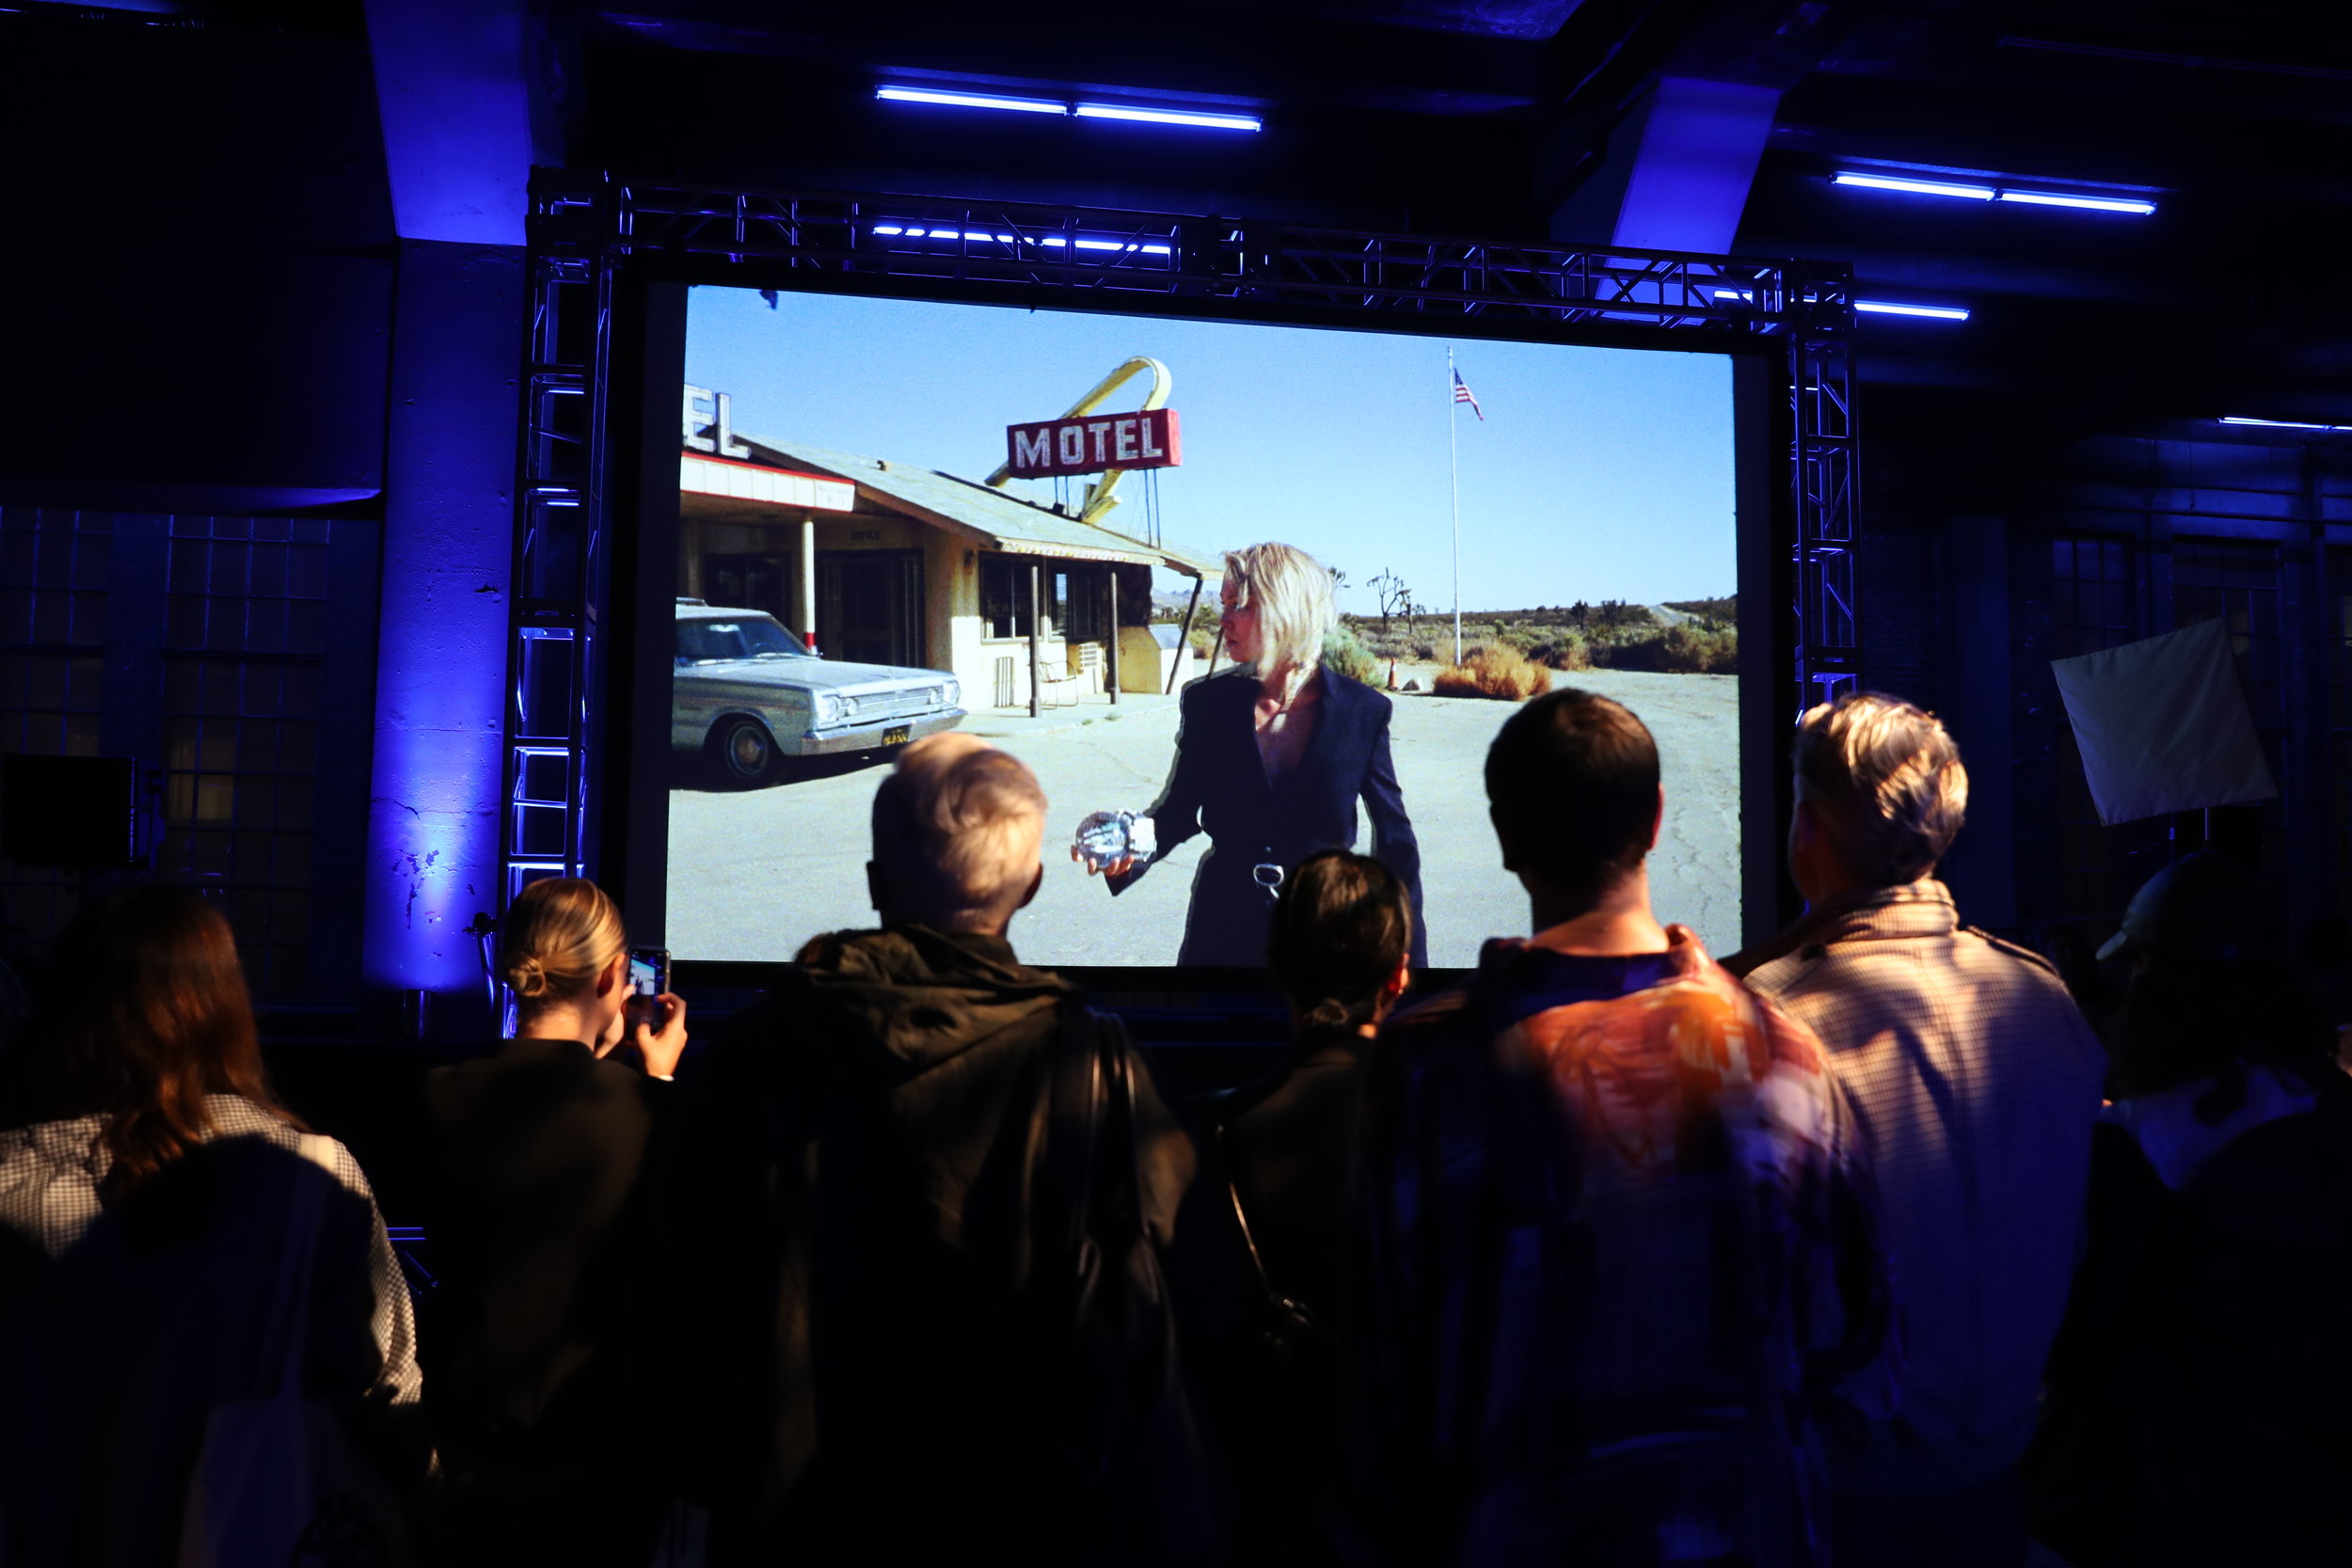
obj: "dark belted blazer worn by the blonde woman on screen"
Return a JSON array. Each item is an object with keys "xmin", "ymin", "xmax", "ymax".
[{"xmin": 1110, "ymin": 665, "xmax": 1430, "ymax": 969}]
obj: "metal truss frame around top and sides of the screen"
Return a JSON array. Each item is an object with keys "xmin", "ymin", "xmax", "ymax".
[{"xmin": 501, "ymin": 169, "xmax": 1861, "ymax": 898}]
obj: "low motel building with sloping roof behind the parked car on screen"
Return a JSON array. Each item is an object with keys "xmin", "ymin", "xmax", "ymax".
[{"xmin": 677, "ymin": 388, "xmax": 1223, "ymax": 712}]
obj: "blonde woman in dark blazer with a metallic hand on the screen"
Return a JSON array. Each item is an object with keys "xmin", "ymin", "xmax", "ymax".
[{"xmin": 1071, "ymin": 543, "xmax": 1430, "ymax": 966}]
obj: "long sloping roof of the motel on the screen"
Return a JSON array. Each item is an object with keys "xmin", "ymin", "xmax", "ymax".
[{"xmin": 682, "ymin": 433, "xmax": 1226, "ymax": 578}]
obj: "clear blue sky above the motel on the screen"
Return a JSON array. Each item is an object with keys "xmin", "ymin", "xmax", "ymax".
[{"xmin": 687, "ymin": 287, "xmax": 1736, "ymax": 613}]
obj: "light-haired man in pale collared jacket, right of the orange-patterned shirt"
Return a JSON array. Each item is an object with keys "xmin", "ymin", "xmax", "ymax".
[{"xmin": 1731, "ymin": 693, "xmax": 2106, "ymax": 1568}]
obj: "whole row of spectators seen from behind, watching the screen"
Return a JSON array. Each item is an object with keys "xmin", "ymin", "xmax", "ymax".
[{"xmin": 0, "ymin": 689, "xmax": 2352, "ymax": 1568}]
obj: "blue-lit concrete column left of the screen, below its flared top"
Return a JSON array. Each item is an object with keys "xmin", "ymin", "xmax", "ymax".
[{"xmin": 362, "ymin": 240, "xmax": 527, "ymax": 997}]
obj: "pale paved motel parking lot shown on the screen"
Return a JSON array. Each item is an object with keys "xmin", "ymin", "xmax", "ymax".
[{"xmin": 668, "ymin": 670, "xmax": 1740, "ymax": 966}]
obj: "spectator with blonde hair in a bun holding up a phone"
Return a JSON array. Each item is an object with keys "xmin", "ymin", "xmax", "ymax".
[{"xmin": 419, "ymin": 877, "xmax": 687, "ymax": 1568}]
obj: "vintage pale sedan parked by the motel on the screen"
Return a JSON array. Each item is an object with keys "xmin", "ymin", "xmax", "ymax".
[{"xmin": 671, "ymin": 599, "xmax": 964, "ymax": 783}]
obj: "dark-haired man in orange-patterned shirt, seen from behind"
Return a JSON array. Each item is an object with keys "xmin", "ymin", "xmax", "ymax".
[{"xmin": 1350, "ymin": 689, "xmax": 1886, "ymax": 1568}]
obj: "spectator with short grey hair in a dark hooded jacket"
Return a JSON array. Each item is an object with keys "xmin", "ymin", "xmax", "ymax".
[{"xmin": 661, "ymin": 734, "xmax": 1214, "ymax": 1568}]
